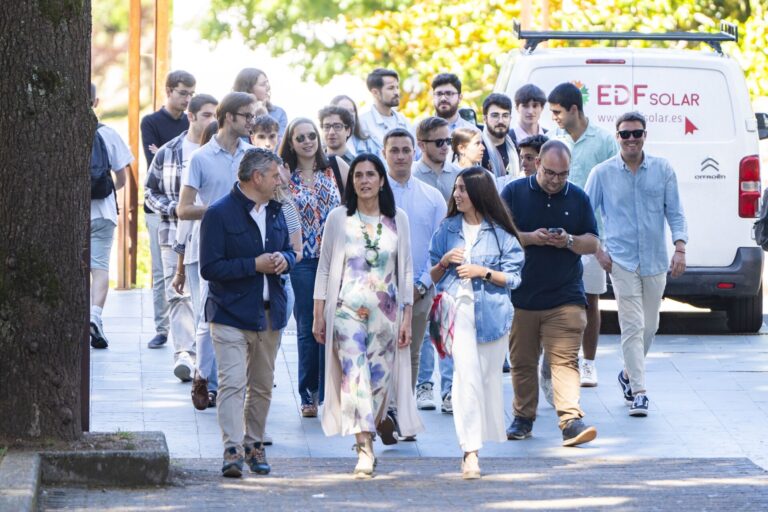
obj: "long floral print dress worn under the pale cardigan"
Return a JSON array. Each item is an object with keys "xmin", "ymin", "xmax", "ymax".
[{"xmin": 333, "ymin": 212, "xmax": 397, "ymax": 435}]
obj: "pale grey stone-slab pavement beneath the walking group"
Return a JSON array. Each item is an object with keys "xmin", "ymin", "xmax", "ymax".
[{"xmin": 91, "ymin": 290, "xmax": 768, "ymax": 468}]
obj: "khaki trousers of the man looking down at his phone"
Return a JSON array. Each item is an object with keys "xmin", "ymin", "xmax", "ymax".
[{"xmin": 509, "ymin": 304, "xmax": 587, "ymax": 429}]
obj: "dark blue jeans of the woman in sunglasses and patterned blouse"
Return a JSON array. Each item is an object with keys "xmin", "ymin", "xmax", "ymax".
[{"xmin": 291, "ymin": 258, "xmax": 325, "ymax": 405}]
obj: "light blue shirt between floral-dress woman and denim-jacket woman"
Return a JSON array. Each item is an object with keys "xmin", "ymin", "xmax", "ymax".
[{"xmin": 388, "ymin": 176, "xmax": 448, "ymax": 288}]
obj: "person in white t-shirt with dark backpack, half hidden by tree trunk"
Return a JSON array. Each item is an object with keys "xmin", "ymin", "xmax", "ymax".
[{"xmin": 90, "ymin": 84, "xmax": 133, "ymax": 348}]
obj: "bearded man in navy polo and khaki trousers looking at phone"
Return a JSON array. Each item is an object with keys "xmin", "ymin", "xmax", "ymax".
[{"xmin": 501, "ymin": 140, "xmax": 599, "ymax": 446}]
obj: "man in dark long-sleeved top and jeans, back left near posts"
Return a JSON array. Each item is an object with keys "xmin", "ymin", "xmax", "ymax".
[{"xmin": 141, "ymin": 70, "xmax": 196, "ymax": 348}]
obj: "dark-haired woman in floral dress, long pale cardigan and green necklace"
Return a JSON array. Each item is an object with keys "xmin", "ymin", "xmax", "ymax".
[{"xmin": 312, "ymin": 153, "xmax": 421, "ymax": 478}]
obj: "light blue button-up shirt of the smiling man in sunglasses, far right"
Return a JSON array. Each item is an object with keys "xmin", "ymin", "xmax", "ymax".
[{"xmin": 586, "ymin": 154, "xmax": 688, "ymax": 276}]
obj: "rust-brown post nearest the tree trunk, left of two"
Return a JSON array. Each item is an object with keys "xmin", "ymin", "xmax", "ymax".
[{"xmin": 117, "ymin": 0, "xmax": 144, "ymax": 290}]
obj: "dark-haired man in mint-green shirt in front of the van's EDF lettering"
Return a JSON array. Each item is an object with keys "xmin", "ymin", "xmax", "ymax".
[{"xmin": 547, "ymin": 82, "xmax": 619, "ymax": 387}]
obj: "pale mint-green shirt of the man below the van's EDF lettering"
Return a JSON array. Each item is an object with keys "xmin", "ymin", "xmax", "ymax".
[{"xmin": 555, "ymin": 120, "xmax": 619, "ymax": 188}]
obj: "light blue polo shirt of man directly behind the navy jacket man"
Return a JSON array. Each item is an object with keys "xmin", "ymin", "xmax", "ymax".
[{"xmin": 182, "ymin": 137, "xmax": 253, "ymax": 206}]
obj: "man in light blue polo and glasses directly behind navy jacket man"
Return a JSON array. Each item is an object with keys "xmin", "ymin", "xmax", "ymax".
[{"xmin": 176, "ymin": 92, "xmax": 256, "ymax": 409}]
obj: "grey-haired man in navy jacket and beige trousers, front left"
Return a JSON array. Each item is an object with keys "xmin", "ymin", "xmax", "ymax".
[{"xmin": 200, "ymin": 148, "xmax": 296, "ymax": 477}]
